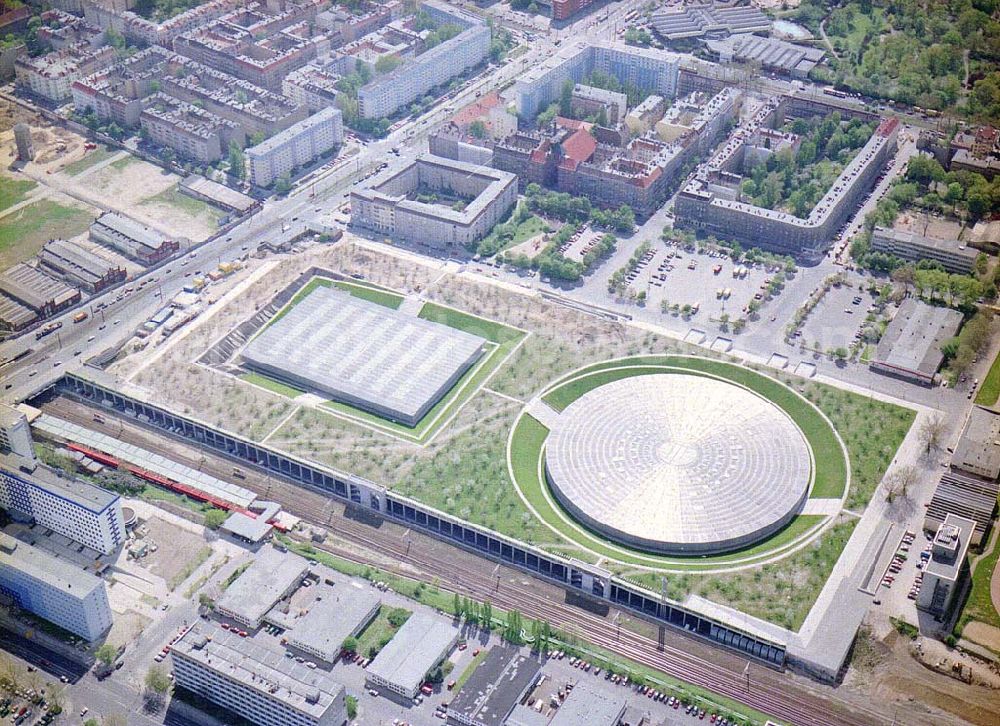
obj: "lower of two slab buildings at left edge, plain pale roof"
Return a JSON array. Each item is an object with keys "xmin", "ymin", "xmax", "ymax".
[{"xmin": 0, "ymin": 533, "xmax": 112, "ymax": 641}]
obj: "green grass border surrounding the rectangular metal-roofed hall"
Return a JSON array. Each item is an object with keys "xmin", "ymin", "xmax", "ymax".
[{"xmin": 240, "ymin": 277, "xmax": 527, "ymax": 443}]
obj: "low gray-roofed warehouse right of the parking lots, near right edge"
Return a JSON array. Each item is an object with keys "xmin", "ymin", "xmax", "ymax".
[{"xmin": 873, "ymin": 298, "xmax": 962, "ymax": 378}]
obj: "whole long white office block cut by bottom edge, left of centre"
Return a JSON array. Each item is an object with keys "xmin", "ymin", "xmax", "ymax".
[{"xmin": 170, "ymin": 622, "xmax": 347, "ymax": 726}]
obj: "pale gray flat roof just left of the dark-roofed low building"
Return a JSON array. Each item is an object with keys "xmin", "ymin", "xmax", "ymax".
[{"xmin": 368, "ymin": 612, "xmax": 458, "ymax": 691}]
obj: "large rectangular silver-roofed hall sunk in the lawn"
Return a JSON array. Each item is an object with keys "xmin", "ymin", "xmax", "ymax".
[{"xmin": 243, "ymin": 287, "xmax": 486, "ymax": 423}]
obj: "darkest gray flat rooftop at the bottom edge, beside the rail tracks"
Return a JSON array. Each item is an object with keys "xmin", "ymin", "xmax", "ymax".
[{"xmin": 448, "ymin": 645, "xmax": 540, "ymax": 726}]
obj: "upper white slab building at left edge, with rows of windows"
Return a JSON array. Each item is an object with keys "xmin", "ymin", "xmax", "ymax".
[{"xmin": 0, "ymin": 454, "xmax": 125, "ymax": 555}]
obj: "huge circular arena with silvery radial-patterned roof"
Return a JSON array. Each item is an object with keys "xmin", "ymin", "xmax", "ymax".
[{"xmin": 544, "ymin": 371, "xmax": 813, "ymax": 555}]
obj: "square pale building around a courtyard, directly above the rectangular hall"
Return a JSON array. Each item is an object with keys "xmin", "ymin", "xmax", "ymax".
[{"xmin": 351, "ymin": 154, "xmax": 517, "ymax": 249}]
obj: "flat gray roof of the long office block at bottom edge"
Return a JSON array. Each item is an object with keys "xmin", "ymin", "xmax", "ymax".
[{"xmin": 171, "ymin": 622, "xmax": 344, "ymax": 720}]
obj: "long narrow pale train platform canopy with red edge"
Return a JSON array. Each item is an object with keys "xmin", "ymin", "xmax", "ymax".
[{"xmin": 32, "ymin": 414, "xmax": 257, "ymax": 509}]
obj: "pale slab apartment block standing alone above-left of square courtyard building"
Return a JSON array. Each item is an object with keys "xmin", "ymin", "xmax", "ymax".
[{"xmin": 246, "ymin": 108, "xmax": 344, "ymax": 187}]
